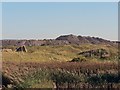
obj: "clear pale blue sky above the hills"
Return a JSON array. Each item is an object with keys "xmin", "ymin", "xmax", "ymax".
[{"xmin": 0, "ymin": 2, "xmax": 118, "ymax": 40}]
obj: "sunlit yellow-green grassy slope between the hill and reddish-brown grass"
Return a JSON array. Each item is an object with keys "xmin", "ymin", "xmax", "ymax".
[{"xmin": 2, "ymin": 44, "xmax": 118, "ymax": 62}]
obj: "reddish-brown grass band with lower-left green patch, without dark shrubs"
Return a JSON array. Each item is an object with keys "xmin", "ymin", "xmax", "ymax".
[{"xmin": 3, "ymin": 61, "xmax": 118, "ymax": 88}]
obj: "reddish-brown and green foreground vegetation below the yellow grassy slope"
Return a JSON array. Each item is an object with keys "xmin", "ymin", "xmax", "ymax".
[{"xmin": 3, "ymin": 61, "xmax": 120, "ymax": 88}]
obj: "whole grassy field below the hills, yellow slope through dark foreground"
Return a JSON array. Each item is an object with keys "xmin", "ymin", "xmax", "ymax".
[{"xmin": 2, "ymin": 44, "xmax": 120, "ymax": 88}]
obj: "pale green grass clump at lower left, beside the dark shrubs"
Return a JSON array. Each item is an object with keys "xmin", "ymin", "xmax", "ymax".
[{"xmin": 17, "ymin": 70, "xmax": 54, "ymax": 88}]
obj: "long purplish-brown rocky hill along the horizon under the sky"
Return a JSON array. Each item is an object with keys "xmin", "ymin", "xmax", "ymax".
[{"xmin": 0, "ymin": 34, "xmax": 116, "ymax": 47}]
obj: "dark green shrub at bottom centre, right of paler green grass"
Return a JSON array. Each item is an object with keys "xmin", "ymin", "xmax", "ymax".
[{"xmin": 51, "ymin": 70, "xmax": 83, "ymax": 88}]
